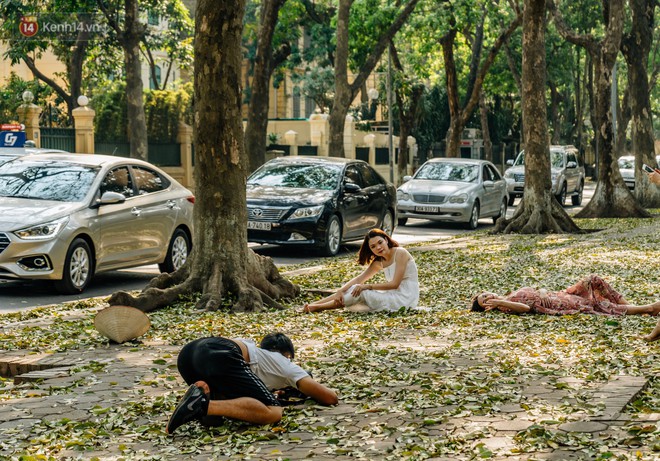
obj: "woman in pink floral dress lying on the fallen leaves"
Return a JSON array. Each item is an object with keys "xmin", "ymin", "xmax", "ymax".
[{"xmin": 472, "ymin": 275, "xmax": 660, "ymax": 322}]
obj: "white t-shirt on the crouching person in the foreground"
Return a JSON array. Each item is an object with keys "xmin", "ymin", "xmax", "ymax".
[{"xmin": 239, "ymin": 338, "xmax": 309, "ymax": 390}]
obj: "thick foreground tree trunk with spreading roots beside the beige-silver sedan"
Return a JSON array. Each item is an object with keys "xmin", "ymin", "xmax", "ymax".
[{"xmin": 109, "ymin": 0, "xmax": 299, "ymax": 312}]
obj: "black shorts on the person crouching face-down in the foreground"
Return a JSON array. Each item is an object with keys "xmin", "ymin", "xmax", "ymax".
[{"xmin": 177, "ymin": 337, "xmax": 280, "ymax": 406}]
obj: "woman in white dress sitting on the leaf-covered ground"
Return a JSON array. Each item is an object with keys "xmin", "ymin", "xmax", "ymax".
[{"xmin": 303, "ymin": 229, "xmax": 419, "ymax": 312}]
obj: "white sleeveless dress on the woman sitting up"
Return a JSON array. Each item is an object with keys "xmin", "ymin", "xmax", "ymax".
[{"xmin": 344, "ymin": 248, "xmax": 419, "ymax": 312}]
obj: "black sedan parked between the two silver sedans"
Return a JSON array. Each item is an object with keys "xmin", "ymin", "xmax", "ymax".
[{"xmin": 247, "ymin": 156, "xmax": 396, "ymax": 255}]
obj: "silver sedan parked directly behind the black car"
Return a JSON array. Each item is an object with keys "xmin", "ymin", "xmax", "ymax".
[{"xmin": 397, "ymin": 158, "xmax": 508, "ymax": 229}]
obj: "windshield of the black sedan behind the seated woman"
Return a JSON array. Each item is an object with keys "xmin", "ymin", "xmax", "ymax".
[{"xmin": 247, "ymin": 163, "xmax": 343, "ymax": 190}]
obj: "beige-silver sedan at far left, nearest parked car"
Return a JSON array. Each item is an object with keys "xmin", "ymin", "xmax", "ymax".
[{"xmin": 0, "ymin": 154, "xmax": 195, "ymax": 293}]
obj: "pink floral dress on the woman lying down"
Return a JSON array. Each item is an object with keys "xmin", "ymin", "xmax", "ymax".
[{"xmin": 506, "ymin": 275, "xmax": 627, "ymax": 315}]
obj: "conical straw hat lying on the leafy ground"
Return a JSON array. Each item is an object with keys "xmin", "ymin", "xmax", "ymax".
[{"xmin": 94, "ymin": 306, "xmax": 151, "ymax": 343}]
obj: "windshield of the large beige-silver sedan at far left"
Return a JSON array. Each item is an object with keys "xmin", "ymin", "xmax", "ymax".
[{"xmin": 0, "ymin": 162, "xmax": 99, "ymax": 202}]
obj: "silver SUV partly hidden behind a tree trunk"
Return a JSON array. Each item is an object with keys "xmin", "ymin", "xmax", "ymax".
[{"xmin": 504, "ymin": 146, "xmax": 584, "ymax": 206}]
